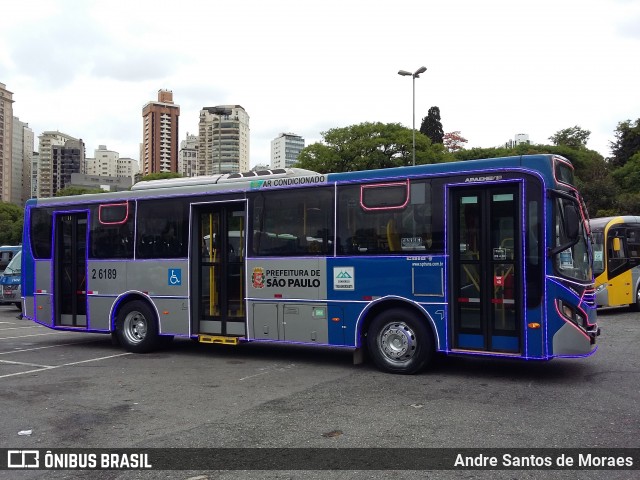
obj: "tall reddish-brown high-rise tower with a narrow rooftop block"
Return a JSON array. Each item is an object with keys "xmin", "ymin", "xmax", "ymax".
[{"xmin": 140, "ymin": 90, "xmax": 180, "ymax": 175}]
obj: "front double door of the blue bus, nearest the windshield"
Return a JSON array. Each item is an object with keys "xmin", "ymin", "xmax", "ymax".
[{"xmin": 449, "ymin": 186, "xmax": 522, "ymax": 353}]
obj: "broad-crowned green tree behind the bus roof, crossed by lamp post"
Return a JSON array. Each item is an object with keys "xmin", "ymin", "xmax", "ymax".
[{"xmin": 296, "ymin": 122, "xmax": 448, "ymax": 173}]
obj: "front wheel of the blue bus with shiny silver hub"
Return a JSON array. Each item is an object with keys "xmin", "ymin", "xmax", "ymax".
[{"xmin": 367, "ymin": 308, "xmax": 435, "ymax": 374}]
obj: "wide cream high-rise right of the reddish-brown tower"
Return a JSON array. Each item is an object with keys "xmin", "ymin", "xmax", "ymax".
[{"xmin": 197, "ymin": 105, "xmax": 249, "ymax": 175}]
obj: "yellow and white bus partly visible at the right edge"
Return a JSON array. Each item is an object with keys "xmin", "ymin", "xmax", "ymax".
[{"xmin": 590, "ymin": 215, "xmax": 640, "ymax": 310}]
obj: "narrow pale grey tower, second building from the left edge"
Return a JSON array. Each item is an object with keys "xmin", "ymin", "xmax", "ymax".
[{"xmin": 10, "ymin": 117, "xmax": 34, "ymax": 207}]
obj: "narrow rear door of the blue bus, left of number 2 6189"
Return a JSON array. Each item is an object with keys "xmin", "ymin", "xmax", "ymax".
[{"xmin": 54, "ymin": 212, "xmax": 87, "ymax": 327}]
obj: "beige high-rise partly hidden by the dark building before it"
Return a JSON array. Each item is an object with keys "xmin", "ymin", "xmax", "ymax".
[{"xmin": 32, "ymin": 131, "xmax": 85, "ymax": 198}]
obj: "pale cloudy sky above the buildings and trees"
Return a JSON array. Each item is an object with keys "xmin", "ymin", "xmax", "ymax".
[{"xmin": 0, "ymin": 0, "xmax": 640, "ymax": 166}]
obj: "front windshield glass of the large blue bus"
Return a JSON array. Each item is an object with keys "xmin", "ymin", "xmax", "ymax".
[{"xmin": 553, "ymin": 197, "xmax": 593, "ymax": 280}]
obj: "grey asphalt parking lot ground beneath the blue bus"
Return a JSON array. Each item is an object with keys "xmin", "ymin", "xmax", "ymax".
[{"xmin": 0, "ymin": 306, "xmax": 640, "ymax": 479}]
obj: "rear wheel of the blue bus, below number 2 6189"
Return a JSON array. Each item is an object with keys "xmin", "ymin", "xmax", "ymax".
[{"xmin": 116, "ymin": 300, "xmax": 159, "ymax": 353}]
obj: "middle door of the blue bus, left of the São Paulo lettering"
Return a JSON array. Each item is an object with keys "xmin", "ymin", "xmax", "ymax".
[{"xmin": 192, "ymin": 203, "xmax": 246, "ymax": 337}]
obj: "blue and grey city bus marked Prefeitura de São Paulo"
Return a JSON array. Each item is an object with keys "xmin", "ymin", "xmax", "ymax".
[{"xmin": 23, "ymin": 155, "xmax": 599, "ymax": 373}]
